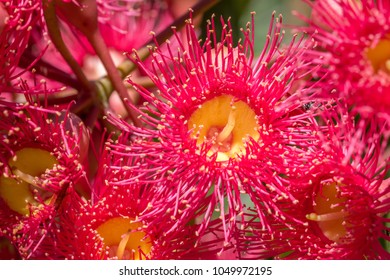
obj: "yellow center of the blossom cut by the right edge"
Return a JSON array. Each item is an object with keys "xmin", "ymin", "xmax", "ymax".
[{"xmin": 367, "ymin": 38, "xmax": 390, "ymax": 74}]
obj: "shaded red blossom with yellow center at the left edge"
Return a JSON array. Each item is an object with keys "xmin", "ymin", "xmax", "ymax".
[{"xmin": 0, "ymin": 96, "xmax": 88, "ymax": 258}]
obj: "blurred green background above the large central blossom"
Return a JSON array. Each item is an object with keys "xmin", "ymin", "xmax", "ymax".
[{"xmin": 202, "ymin": 0, "xmax": 309, "ymax": 53}]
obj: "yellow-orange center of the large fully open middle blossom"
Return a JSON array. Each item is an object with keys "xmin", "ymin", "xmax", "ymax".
[{"xmin": 188, "ymin": 95, "xmax": 260, "ymax": 161}]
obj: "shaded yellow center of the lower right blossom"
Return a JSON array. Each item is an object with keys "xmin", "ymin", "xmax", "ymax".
[{"xmin": 306, "ymin": 182, "xmax": 348, "ymax": 242}]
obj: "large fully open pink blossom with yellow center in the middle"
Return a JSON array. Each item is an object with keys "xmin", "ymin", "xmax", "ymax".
[{"xmin": 105, "ymin": 12, "xmax": 324, "ymax": 250}]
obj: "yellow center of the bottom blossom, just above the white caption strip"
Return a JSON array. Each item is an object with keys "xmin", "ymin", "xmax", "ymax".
[{"xmin": 96, "ymin": 217, "xmax": 152, "ymax": 260}]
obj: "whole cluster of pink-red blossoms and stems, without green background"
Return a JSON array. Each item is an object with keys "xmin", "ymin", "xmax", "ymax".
[{"xmin": 0, "ymin": 0, "xmax": 390, "ymax": 260}]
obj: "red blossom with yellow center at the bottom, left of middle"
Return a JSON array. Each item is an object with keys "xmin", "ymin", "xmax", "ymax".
[{"xmin": 54, "ymin": 137, "xmax": 230, "ymax": 259}]
